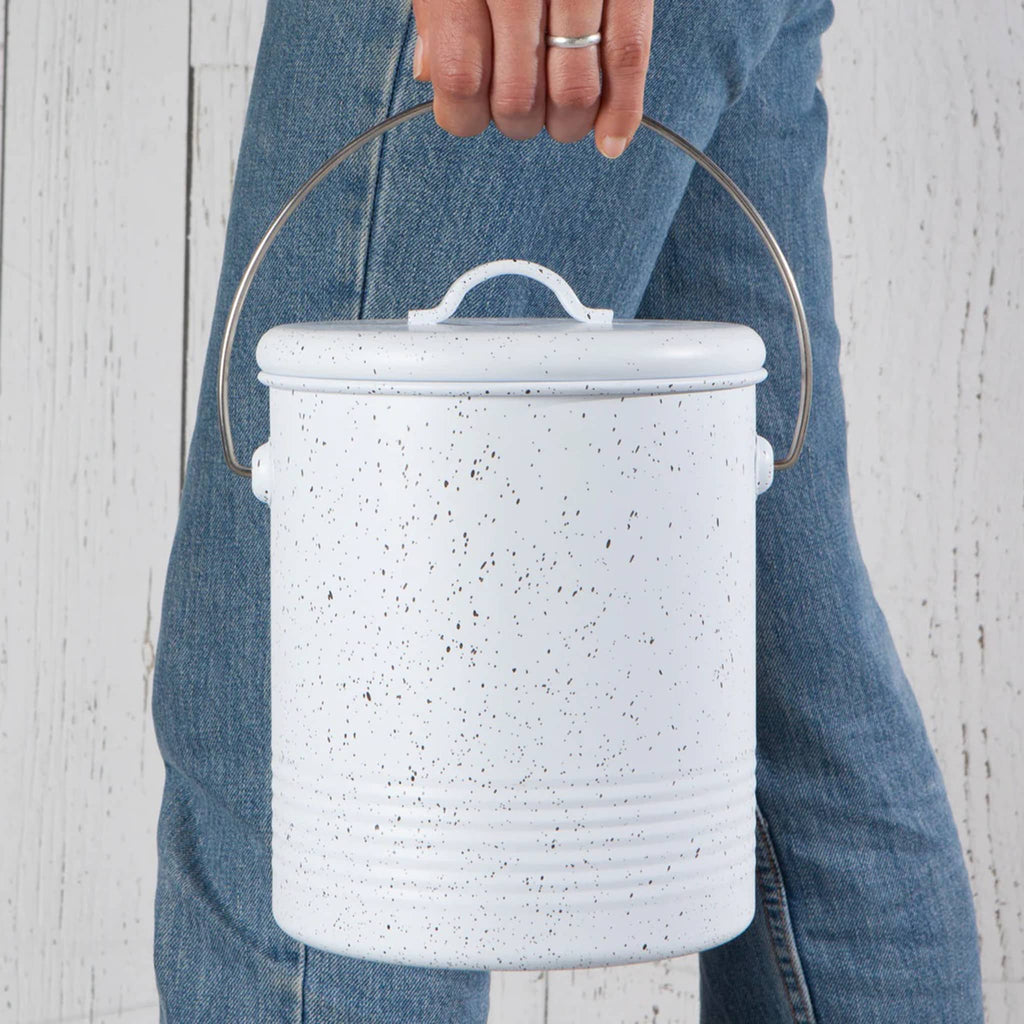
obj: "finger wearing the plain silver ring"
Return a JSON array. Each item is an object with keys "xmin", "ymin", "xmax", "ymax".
[{"xmin": 547, "ymin": 0, "xmax": 602, "ymax": 142}]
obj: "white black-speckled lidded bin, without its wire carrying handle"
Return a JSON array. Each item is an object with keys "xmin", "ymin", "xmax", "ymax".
[{"xmin": 253, "ymin": 260, "xmax": 772, "ymax": 970}]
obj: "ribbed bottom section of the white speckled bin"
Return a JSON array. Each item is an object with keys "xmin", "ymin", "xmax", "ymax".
[{"xmin": 273, "ymin": 758, "xmax": 755, "ymax": 971}]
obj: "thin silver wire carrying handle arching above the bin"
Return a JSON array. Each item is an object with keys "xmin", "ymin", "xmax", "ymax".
[{"xmin": 217, "ymin": 99, "xmax": 813, "ymax": 477}]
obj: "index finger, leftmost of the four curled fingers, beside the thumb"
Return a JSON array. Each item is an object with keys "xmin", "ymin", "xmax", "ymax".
[{"xmin": 427, "ymin": 0, "xmax": 492, "ymax": 135}]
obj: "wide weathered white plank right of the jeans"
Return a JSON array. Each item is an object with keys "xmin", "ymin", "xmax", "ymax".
[{"xmin": 825, "ymin": 0, "xmax": 1024, "ymax": 999}]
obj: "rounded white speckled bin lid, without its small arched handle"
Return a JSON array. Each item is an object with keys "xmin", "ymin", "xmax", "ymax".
[{"xmin": 256, "ymin": 317, "xmax": 765, "ymax": 390}]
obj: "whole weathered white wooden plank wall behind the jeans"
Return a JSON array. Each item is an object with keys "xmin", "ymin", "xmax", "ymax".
[{"xmin": 0, "ymin": 0, "xmax": 1024, "ymax": 1024}]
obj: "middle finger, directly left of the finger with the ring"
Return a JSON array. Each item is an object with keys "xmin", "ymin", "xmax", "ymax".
[{"xmin": 488, "ymin": 0, "xmax": 547, "ymax": 139}]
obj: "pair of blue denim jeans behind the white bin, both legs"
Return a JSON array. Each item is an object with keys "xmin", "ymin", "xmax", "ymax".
[{"xmin": 154, "ymin": 0, "xmax": 982, "ymax": 1024}]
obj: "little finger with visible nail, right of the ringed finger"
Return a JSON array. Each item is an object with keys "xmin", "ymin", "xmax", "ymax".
[{"xmin": 594, "ymin": 0, "xmax": 654, "ymax": 158}]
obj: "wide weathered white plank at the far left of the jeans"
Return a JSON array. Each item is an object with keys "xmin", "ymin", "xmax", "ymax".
[{"xmin": 0, "ymin": 0, "xmax": 187, "ymax": 1024}]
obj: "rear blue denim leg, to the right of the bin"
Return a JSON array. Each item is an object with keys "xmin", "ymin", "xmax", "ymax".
[{"xmin": 640, "ymin": 5, "xmax": 982, "ymax": 1024}]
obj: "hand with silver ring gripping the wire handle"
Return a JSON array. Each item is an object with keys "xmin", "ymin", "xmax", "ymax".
[{"xmin": 413, "ymin": 0, "xmax": 654, "ymax": 158}]
